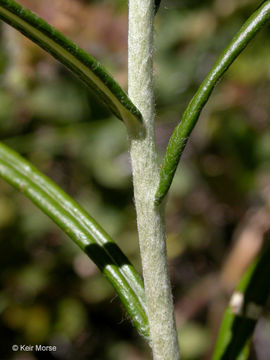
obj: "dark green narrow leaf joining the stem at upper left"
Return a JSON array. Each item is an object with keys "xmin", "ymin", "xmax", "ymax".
[{"xmin": 0, "ymin": 0, "xmax": 142, "ymax": 131}]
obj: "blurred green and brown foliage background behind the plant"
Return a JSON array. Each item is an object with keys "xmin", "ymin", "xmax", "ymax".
[{"xmin": 0, "ymin": 0, "xmax": 270, "ymax": 360}]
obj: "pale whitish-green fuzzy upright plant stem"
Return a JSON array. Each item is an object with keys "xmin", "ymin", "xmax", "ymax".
[{"xmin": 129, "ymin": 0, "xmax": 180, "ymax": 360}]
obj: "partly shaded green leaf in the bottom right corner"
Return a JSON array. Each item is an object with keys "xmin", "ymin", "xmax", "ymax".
[{"xmin": 212, "ymin": 244, "xmax": 270, "ymax": 360}]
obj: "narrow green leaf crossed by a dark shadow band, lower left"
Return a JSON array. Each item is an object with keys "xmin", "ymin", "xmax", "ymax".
[{"xmin": 0, "ymin": 143, "xmax": 149, "ymax": 337}]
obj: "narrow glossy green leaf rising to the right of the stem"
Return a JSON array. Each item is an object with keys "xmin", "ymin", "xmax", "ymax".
[{"xmin": 155, "ymin": 1, "xmax": 270, "ymax": 205}]
